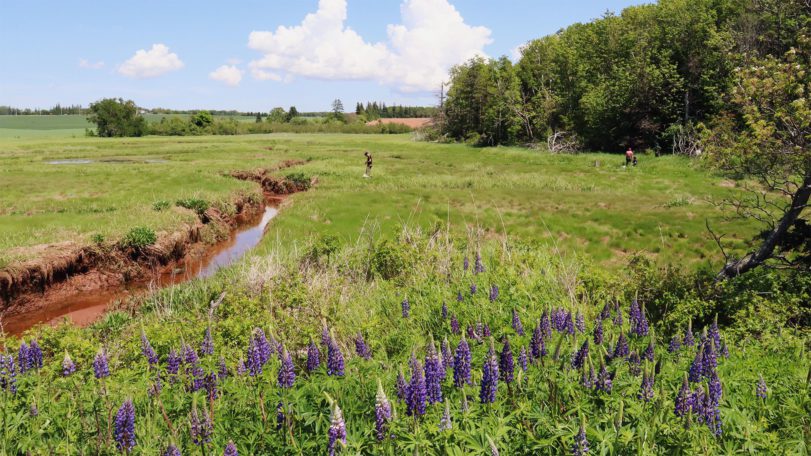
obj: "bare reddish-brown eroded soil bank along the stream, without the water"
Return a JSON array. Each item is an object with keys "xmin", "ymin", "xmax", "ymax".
[{"xmin": 0, "ymin": 160, "xmax": 317, "ymax": 333}]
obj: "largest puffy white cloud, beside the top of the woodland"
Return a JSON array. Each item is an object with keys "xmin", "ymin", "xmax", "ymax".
[{"xmin": 248, "ymin": 0, "xmax": 492, "ymax": 91}]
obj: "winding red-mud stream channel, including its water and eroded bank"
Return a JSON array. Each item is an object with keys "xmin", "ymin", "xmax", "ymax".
[{"xmin": 0, "ymin": 161, "xmax": 316, "ymax": 335}]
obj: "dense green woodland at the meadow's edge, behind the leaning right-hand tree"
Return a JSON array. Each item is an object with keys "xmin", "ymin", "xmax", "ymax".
[{"xmin": 442, "ymin": 0, "xmax": 811, "ymax": 152}]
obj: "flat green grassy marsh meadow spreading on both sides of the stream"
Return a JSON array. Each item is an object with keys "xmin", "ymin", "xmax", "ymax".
[{"xmin": 0, "ymin": 134, "xmax": 755, "ymax": 267}]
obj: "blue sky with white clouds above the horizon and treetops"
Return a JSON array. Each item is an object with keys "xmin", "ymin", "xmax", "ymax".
[{"xmin": 0, "ymin": 0, "xmax": 645, "ymax": 111}]
